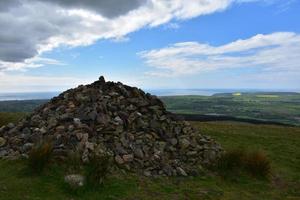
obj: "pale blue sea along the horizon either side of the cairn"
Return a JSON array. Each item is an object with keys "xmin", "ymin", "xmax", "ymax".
[{"xmin": 0, "ymin": 89, "xmax": 296, "ymax": 101}]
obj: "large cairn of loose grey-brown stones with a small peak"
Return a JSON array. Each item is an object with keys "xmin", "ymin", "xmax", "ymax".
[{"xmin": 0, "ymin": 77, "xmax": 222, "ymax": 176}]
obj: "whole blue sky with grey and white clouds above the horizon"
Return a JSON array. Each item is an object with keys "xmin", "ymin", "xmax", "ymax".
[{"xmin": 0, "ymin": 0, "xmax": 300, "ymax": 93}]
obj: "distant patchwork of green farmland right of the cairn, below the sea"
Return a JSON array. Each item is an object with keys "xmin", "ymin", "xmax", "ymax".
[{"xmin": 161, "ymin": 92, "xmax": 300, "ymax": 125}]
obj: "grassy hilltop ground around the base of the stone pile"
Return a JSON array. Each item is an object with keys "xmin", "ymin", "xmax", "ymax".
[{"xmin": 0, "ymin": 113, "xmax": 300, "ymax": 200}]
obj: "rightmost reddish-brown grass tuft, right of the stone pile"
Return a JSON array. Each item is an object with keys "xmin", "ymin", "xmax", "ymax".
[{"xmin": 245, "ymin": 151, "xmax": 271, "ymax": 177}]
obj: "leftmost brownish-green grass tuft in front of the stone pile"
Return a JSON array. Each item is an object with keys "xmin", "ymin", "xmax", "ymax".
[{"xmin": 28, "ymin": 140, "xmax": 53, "ymax": 174}]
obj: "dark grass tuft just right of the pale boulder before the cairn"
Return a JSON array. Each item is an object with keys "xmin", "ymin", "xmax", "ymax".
[{"xmin": 86, "ymin": 154, "xmax": 112, "ymax": 186}]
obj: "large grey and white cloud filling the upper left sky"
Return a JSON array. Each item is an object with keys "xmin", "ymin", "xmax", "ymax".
[{"xmin": 0, "ymin": 0, "xmax": 241, "ymax": 69}]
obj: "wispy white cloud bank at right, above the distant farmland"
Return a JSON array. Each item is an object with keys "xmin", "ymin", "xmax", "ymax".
[{"xmin": 139, "ymin": 32, "xmax": 300, "ymax": 76}]
